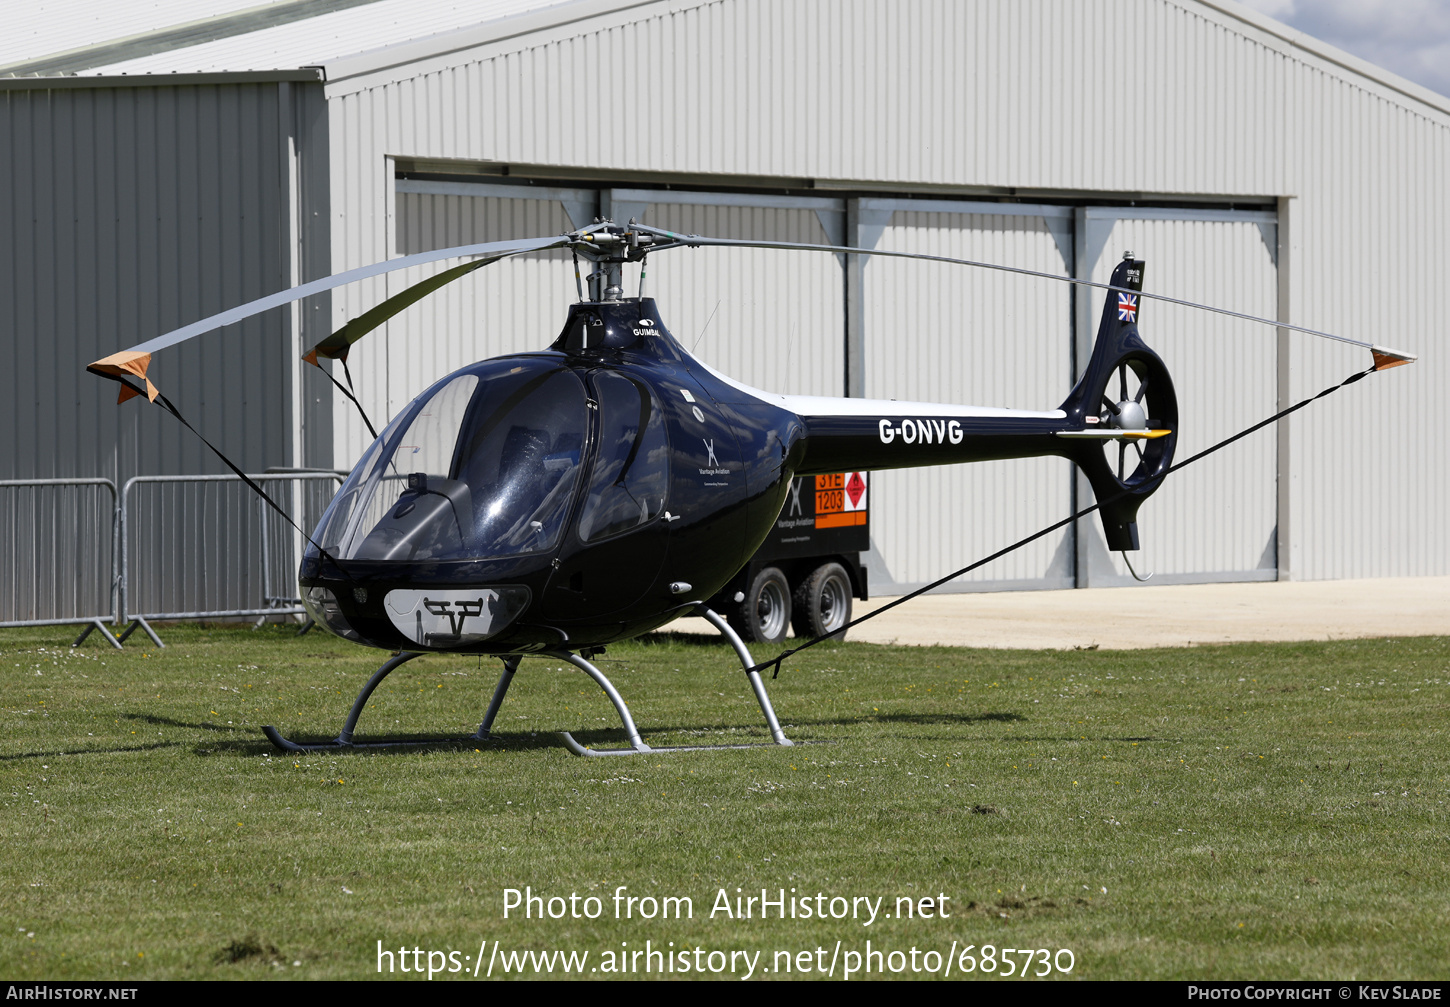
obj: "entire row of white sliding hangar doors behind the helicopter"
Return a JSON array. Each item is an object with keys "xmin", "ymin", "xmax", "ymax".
[{"xmin": 391, "ymin": 178, "xmax": 1277, "ymax": 593}]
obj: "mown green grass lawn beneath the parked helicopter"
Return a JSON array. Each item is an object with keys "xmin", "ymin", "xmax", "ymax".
[{"xmin": 0, "ymin": 627, "xmax": 1450, "ymax": 979}]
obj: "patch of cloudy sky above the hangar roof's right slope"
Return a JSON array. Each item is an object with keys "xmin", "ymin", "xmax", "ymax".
[{"xmin": 1240, "ymin": 0, "xmax": 1450, "ymax": 94}]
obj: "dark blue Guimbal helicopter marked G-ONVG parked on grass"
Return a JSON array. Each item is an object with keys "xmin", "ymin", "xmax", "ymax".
[{"xmin": 88, "ymin": 219, "xmax": 1414, "ymax": 756}]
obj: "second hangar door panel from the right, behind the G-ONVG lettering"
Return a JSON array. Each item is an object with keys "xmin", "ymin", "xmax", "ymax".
[{"xmin": 861, "ymin": 200, "xmax": 1073, "ymax": 591}]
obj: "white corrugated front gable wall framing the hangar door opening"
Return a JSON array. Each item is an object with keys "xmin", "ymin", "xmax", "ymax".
[{"xmin": 328, "ymin": 0, "xmax": 1450, "ymax": 579}]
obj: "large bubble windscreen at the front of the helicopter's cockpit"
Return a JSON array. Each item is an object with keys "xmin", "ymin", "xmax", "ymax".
[{"xmin": 311, "ymin": 358, "xmax": 589, "ymax": 562}]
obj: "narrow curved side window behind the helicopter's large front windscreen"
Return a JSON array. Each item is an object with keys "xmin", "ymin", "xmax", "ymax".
[{"xmin": 579, "ymin": 371, "xmax": 670, "ymax": 541}]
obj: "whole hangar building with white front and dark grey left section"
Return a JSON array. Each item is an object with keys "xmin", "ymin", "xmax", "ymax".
[{"xmin": 0, "ymin": 0, "xmax": 1450, "ymax": 618}]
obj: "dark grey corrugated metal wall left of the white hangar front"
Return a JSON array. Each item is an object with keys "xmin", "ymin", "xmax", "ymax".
[{"xmin": 0, "ymin": 84, "xmax": 301, "ymax": 482}]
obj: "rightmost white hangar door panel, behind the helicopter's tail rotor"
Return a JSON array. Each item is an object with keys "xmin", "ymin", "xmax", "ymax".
[{"xmin": 1077, "ymin": 207, "xmax": 1279, "ymax": 585}]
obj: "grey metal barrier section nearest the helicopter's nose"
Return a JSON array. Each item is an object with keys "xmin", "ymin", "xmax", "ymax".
[{"xmin": 119, "ymin": 472, "xmax": 345, "ymax": 646}]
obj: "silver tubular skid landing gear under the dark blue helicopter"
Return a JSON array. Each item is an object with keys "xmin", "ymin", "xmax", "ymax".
[{"xmin": 262, "ymin": 605, "xmax": 795, "ymax": 757}]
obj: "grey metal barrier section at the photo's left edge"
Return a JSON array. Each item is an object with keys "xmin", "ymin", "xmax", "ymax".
[{"xmin": 0, "ymin": 479, "xmax": 120, "ymax": 647}]
